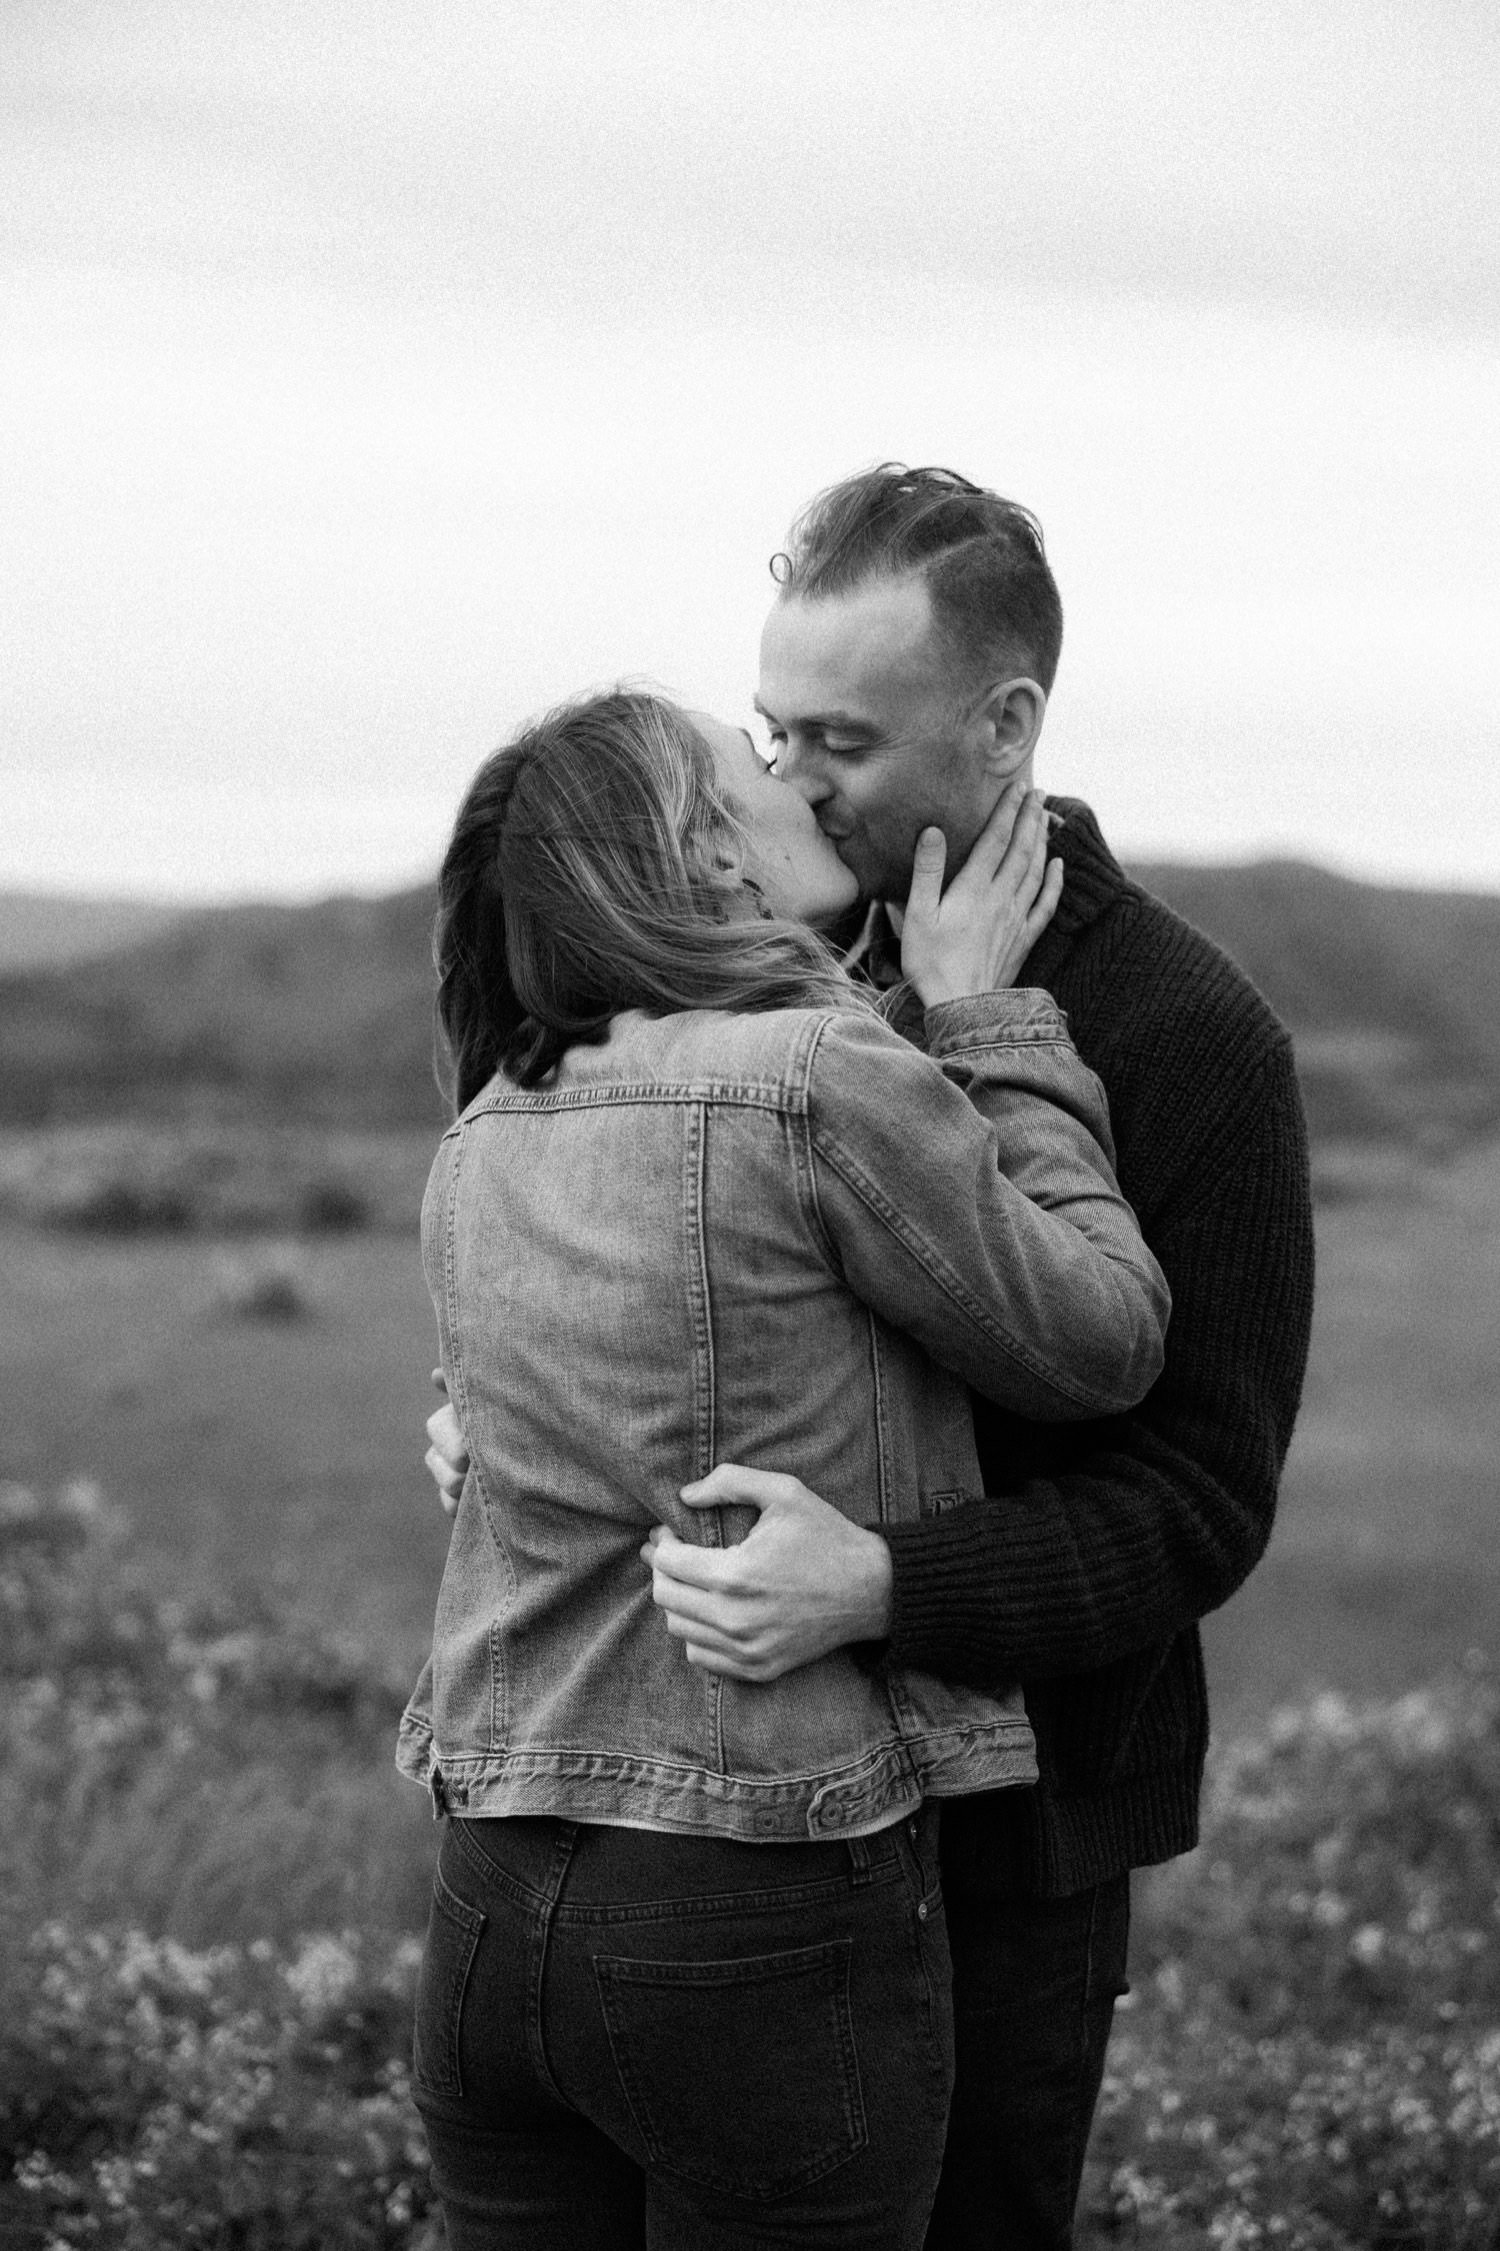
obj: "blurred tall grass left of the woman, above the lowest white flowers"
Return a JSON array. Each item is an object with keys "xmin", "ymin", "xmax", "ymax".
[{"xmin": 0, "ymin": 1486, "xmax": 432, "ymax": 1945}]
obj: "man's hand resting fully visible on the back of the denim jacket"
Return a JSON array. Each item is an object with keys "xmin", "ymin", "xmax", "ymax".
[{"xmin": 642, "ymin": 1461, "xmax": 892, "ymax": 1681}]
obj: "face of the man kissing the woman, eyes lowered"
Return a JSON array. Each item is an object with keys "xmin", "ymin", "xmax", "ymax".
[{"xmin": 757, "ymin": 579, "xmax": 998, "ymax": 900}]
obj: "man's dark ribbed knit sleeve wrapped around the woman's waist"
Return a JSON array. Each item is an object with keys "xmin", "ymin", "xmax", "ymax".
[{"xmin": 883, "ymin": 1040, "xmax": 1313, "ymax": 1684}]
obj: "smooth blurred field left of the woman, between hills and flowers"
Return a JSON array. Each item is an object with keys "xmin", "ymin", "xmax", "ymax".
[{"xmin": 0, "ymin": 1227, "xmax": 448, "ymax": 1666}]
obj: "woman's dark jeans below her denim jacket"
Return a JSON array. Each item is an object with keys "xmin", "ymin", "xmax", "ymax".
[{"xmin": 414, "ymin": 1814, "xmax": 953, "ymax": 2251}]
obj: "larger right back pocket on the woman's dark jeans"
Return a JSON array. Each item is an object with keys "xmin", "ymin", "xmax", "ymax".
[{"xmin": 595, "ymin": 1938, "xmax": 867, "ymax": 2201}]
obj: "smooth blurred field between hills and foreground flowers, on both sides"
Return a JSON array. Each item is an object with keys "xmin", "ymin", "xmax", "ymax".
[{"xmin": 0, "ymin": 1146, "xmax": 1500, "ymax": 1729}]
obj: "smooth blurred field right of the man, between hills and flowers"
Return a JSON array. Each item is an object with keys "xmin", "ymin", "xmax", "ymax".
[{"xmin": 1207, "ymin": 1144, "xmax": 1500, "ymax": 1729}]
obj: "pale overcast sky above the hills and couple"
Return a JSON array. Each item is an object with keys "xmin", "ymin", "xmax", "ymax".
[{"xmin": 0, "ymin": 0, "xmax": 1500, "ymax": 896}]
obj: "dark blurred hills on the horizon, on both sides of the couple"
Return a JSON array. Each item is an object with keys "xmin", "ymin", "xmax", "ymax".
[{"xmin": 0, "ymin": 860, "xmax": 1500, "ymax": 1155}]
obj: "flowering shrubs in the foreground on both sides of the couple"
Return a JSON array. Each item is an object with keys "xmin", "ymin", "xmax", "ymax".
[{"xmin": 0, "ymin": 1486, "xmax": 1500, "ymax": 2251}]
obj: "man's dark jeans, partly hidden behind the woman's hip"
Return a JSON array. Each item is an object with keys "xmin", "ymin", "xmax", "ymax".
[{"xmin": 928, "ymin": 1801, "xmax": 1131, "ymax": 2251}]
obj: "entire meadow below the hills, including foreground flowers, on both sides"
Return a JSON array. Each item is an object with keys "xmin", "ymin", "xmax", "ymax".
[{"xmin": 0, "ymin": 1139, "xmax": 1500, "ymax": 2251}]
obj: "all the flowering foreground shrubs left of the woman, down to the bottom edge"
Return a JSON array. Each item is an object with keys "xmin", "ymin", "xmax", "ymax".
[{"xmin": 0, "ymin": 1483, "xmax": 439, "ymax": 2251}]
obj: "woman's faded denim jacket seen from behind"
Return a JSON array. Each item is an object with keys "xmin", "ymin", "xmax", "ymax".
[{"xmin": 399, "ymin": 993, "xmax": 1167, "ymax": 1841}]
